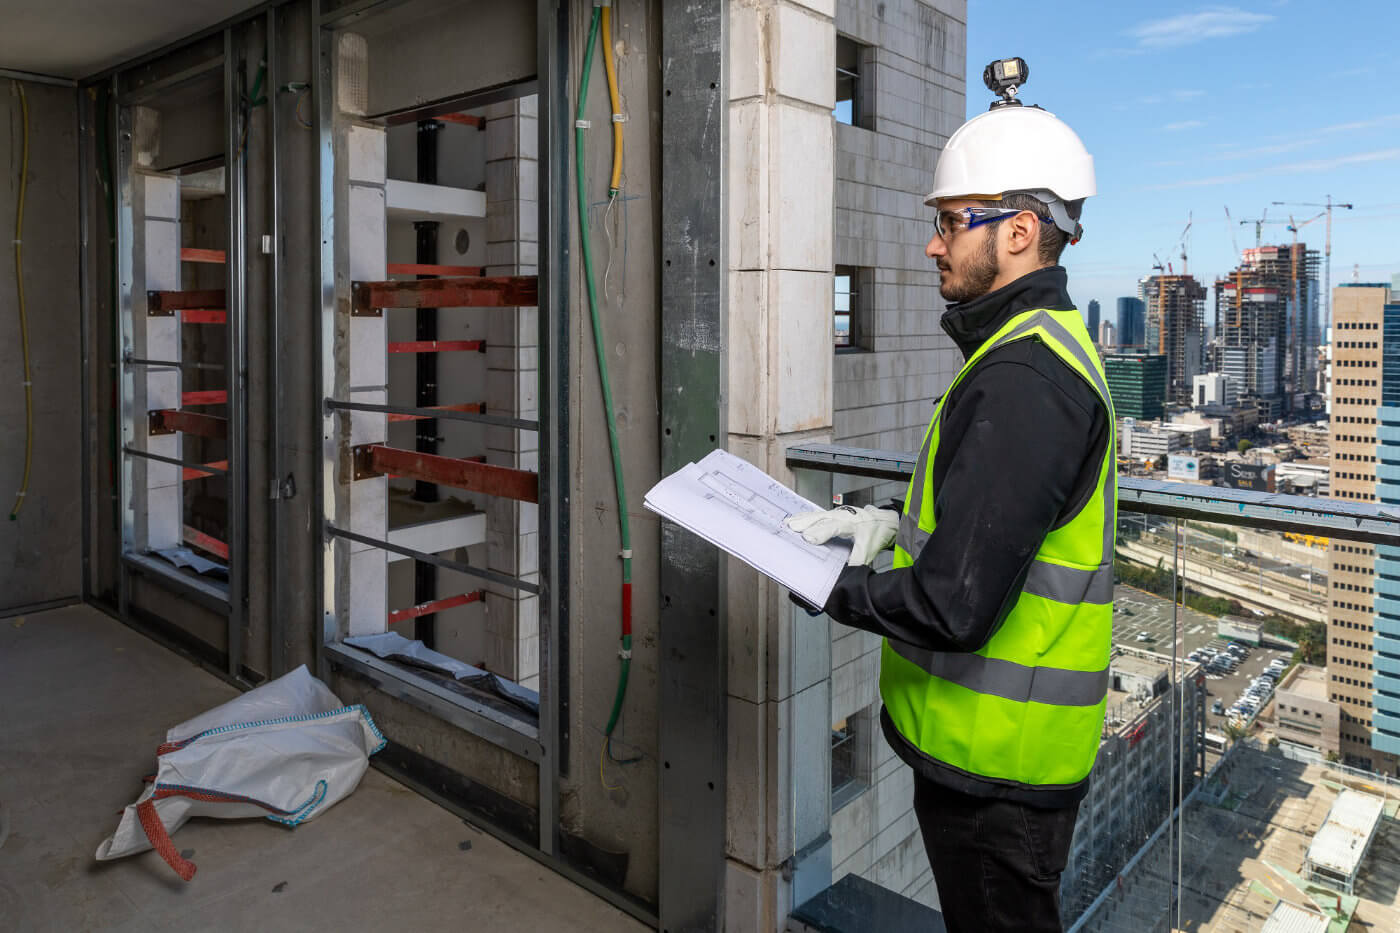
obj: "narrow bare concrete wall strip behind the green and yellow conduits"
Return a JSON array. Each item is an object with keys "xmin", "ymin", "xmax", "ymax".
[{"xmin": 560, "ymin": 0, "xmax": 663, "ymax": 901}]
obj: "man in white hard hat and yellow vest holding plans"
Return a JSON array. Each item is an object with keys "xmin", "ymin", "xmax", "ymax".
[{"xmin": 790, "ymin": 59, "xmax": 1117, "ymax": 932}]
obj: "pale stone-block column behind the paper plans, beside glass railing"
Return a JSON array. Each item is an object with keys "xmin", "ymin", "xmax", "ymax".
[{"xmin": 725, "ymin": 0, "xmax": 836, "ymax": 932}]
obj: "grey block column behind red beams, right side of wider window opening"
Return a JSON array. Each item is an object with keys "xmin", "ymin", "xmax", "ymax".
[{"xmin": 484, "ymin": 97, "xmax": 539, "ymax": 688}]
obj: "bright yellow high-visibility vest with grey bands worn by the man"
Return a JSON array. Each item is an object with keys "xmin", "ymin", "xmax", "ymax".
[{"xmin": 879, "ymin": 310, "xmax": 1117, "ymax": 790}]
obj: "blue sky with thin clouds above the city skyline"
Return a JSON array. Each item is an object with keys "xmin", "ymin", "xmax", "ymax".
[{"xmin": 967, "ymin": 0, "xmax": 1400, "ymax": 321}]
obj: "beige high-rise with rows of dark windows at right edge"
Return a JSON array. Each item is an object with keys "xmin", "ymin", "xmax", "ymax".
[{"xmin": 1327, "ymin": 284, "xmax": 1400, "ymax": 773}]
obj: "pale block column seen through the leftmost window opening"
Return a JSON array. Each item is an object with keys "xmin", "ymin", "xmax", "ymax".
[{"xmin": 129, "ymin": 165, "xmax": 183, "ymax": 551}]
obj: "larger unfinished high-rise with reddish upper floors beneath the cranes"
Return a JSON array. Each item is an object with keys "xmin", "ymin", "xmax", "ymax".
[{"xmin": 1215, "ymin": 244, "xmax": 1322, "ymax": 417}]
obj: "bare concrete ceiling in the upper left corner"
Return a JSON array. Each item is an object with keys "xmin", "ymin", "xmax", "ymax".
[{"xmin": 0, "ymin": 0, "xmax": 259, "ymax": 78}]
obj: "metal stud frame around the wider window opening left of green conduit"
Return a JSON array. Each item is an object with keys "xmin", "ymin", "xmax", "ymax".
[{"xmin": 314, "ymin": 0, "xmax": 576, "ymax": 902}]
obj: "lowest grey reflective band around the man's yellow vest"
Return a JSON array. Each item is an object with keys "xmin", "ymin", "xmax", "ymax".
[{"xmin": 889, "ymin": 639, "xmax": 1109, "ymax": 706}]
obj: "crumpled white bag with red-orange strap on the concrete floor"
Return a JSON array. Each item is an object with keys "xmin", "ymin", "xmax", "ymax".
[{"xmin": 97, "ymin": 665, "xmax": 386, "ymax": 881}]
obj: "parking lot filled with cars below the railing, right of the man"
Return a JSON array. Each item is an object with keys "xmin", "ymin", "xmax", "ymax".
[{"xmin": 1113, "ymin": 584, "xmax": 1291, "ymax": 731}]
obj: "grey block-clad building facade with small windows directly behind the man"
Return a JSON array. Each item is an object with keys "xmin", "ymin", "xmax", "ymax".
[{"xmin": 832, "ymin": 0, "xmax": 967, "ymax": 905}]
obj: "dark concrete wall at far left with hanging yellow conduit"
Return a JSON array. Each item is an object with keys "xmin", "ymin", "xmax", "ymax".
[{"xmin": 0, "ymin": 80, "xmax": 83, "ymax": 612}]
